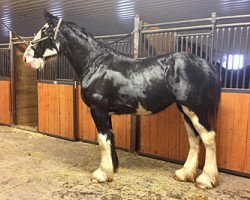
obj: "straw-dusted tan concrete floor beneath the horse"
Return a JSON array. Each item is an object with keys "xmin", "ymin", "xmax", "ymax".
[{"xmin": 0, "ymin": 126, "xmax": 250, "ymax": 200}]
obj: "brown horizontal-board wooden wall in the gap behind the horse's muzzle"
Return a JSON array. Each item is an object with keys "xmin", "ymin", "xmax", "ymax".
[{"xmin": 14, "ymin": 44, "xmax": 37, "ymax": 127}]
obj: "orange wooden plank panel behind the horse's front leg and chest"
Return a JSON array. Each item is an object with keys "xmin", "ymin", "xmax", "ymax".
[{"xmin": 76, "ymin": 86, "xmax": 131, "ymax": 149}]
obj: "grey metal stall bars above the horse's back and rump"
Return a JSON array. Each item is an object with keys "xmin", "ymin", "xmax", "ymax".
[{"xmin": 140, "ymin": 13, "xmax": 250, "ymax": 93}]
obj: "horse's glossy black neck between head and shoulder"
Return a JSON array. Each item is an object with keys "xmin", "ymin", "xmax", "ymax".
[{"xmin": 63, "ymin": 26, "xmax": 105, "ymax": 78}]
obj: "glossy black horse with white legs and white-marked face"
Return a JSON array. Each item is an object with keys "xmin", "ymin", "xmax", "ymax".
[{"xmin": 23, "ymin": 10, "xmax": 220, "ymax": 188}]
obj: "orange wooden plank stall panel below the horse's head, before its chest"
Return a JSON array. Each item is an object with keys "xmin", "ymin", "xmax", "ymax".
[{"xmin": 38, "ymin": 83, "xmax": 74, "ymax": 139}]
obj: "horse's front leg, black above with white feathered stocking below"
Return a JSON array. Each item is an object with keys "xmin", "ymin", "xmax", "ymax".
[{"xmin": 91, "ymin": 107, "xmax": 118, "ymax": 183}]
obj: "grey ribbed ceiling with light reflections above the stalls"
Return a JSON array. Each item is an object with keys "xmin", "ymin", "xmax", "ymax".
[{"xmin": 0, "ymin": 0, "xmax": 250, "ymax": 43}]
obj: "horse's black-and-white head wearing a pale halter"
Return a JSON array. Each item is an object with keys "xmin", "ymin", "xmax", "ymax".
[{"xmin": 23, "ymin": 10, "xmax": 64, "ymax": 69}]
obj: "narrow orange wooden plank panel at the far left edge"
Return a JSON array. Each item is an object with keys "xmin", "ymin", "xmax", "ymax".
[{"xmin": 0, "ymin": 80, "xmax": 11, "ymax": 125}]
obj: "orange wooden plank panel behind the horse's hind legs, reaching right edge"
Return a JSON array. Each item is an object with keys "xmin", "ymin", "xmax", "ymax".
[{"xmin": 140, "ymin": 93, "xmax": 250, "ymax": 174}]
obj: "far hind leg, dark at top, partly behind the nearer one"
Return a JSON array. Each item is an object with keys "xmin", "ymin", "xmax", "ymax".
[{"xmin": 175, "ymin": 108, "xmax": 200, "ymax": 182}]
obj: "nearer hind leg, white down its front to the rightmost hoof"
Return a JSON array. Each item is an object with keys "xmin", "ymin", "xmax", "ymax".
[{"xmin": 182, "ymin": 106, "xmax": 218, "ymax": 188}]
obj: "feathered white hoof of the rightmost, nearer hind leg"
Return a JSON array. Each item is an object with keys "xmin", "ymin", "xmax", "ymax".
[{"xmin": 195, "ymin": 172, "xmax": 218, "ymax": 189}]
